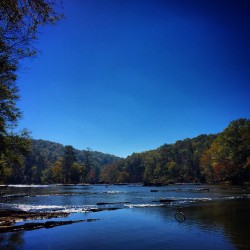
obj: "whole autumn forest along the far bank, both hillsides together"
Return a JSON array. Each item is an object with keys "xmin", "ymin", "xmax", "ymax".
[{"xmin": 0, "ymin": 119, "xmax": 250, "ymax": 185}]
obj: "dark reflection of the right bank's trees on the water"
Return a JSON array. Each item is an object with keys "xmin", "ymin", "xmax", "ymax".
[{"xmin": 184, "ymin": 200, "xmax": 250, "ymax": 249}]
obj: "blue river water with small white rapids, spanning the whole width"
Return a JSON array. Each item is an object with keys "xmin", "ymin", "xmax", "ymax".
[{"xmin": 0, "ymin": 185, "xmax": 250, "ymax": 250}]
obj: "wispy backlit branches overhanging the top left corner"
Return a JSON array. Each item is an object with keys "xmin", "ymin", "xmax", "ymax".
[{"xmin": 0, "ymin": 0, "xmax": 63, "ymax": 62}]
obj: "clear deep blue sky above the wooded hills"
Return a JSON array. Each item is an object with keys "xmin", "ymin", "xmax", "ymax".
[{"xmin": 18, "ymin": 0, "xmax": 250, "ymax": 157}]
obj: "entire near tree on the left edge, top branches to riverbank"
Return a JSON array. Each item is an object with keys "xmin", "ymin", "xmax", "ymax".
[{"xmin": 0, "ymin": 0, "xmax": 62, "ymax": 184}]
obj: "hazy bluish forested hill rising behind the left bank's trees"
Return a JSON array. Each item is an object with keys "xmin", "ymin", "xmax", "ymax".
[{"xmin": 22, "ymin": 139, "xmax": 121, "ymax": 183}]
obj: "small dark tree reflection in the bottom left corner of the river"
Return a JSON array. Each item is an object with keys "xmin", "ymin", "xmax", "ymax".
[{"xmin": 0, "ymin": 232, "xmax": 24, "ymax": 250}]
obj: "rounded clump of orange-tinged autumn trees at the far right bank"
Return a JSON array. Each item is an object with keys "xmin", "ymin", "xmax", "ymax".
[{"xmin": 201, "ymin": 119, "xmax": 250, "ymax": 184}]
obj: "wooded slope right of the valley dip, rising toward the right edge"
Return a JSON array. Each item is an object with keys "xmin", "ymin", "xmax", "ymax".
[{"xmin": 101, "ymin": 119, "xmax": 250, "ymax": 185}]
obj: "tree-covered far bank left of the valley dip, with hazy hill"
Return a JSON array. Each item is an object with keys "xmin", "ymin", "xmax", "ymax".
[{"xmin": 0, "ymin": 140, "xmax": 120, "ymax": 184}]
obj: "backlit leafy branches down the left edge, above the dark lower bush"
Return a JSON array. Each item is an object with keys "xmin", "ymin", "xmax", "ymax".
[{"xmin": 0, "ymin": 0, "xmax": 62, "ymax": 135}]
